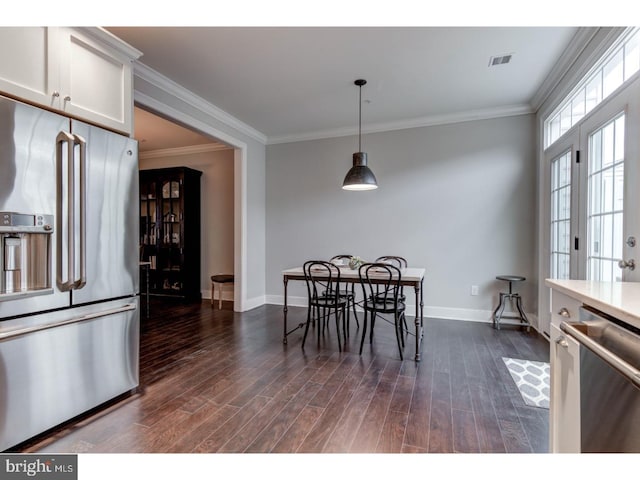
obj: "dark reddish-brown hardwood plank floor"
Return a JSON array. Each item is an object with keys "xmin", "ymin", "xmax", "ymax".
[{"xmin": 14, "ymin": 301, "xmax": 549, "ymax": 453}]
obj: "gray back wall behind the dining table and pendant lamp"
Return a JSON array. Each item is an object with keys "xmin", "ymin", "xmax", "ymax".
[{"xmin": 266, "ymin": 115, "xmax": 537, "ymax": 320}]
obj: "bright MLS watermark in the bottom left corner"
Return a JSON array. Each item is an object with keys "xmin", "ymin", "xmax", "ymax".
[{"xmin": 0, "ymin": 454, "xmax": 78, "ymax": 480}]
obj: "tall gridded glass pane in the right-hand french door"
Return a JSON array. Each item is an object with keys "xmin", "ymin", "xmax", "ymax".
[{"xmin": 587, "ymin": 114, "xmax": 624, "ymax": 281}]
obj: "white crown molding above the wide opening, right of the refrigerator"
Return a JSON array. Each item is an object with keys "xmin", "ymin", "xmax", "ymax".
[{"xmin": 133, "ymin": 62, "xmax": 267, "ymax": 144}]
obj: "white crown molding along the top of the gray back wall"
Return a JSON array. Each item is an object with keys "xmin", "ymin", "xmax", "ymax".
[{"xmin": 267, "ymin": 105, "xmax": 535, "ymax": 145}]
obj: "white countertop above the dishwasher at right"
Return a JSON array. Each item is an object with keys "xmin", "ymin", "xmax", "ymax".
[{"xmin": 545, "ymin": 279, "xmax": 640, "ymax": 328}]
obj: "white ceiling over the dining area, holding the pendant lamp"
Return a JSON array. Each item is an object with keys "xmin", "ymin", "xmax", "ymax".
[{"xmin": 107, "ymin": 27, "xmax": 592, "ymax": 148}]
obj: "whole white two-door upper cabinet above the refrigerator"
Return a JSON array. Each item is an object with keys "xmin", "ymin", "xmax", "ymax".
[{"xmin": 0, "ymin": 27, "xmax": 140, "ymax": 135}]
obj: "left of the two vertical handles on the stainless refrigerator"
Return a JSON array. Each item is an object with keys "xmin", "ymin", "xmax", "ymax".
[{"xmin": 56, "ymin": 131, "xmax": 75, "ymax": 292}]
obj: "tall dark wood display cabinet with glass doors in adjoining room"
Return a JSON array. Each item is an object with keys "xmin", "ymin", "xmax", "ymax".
[{"xmin": 140, "ymin": 167, "xmax": 202, "ymax": 301}]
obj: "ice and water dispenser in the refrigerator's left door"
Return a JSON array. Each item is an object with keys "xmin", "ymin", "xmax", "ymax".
[{"xmin": 0, "ymin": 212, "xmax": 53, "ymax": 301}]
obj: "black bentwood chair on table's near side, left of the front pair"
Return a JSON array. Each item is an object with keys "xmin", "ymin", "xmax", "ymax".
[{"xmin": 302, "ymin": 260, "xmax": 347, "ymax": 351}]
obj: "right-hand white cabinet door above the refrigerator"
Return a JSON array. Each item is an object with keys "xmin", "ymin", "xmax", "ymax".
[{"xmin": 58, "ymin": 28, "xmax": 133, "ymax": 133}]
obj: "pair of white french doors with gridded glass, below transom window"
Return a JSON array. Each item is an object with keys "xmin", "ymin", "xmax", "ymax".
[{"xmin": 545, "ymin": 74, "xmax": 640, "ymax": 282}]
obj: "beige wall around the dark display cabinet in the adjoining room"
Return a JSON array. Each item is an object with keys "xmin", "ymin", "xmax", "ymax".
[{"xmin": 139, "ymin": 149, "xmax": 234, "ymax": 300}]
